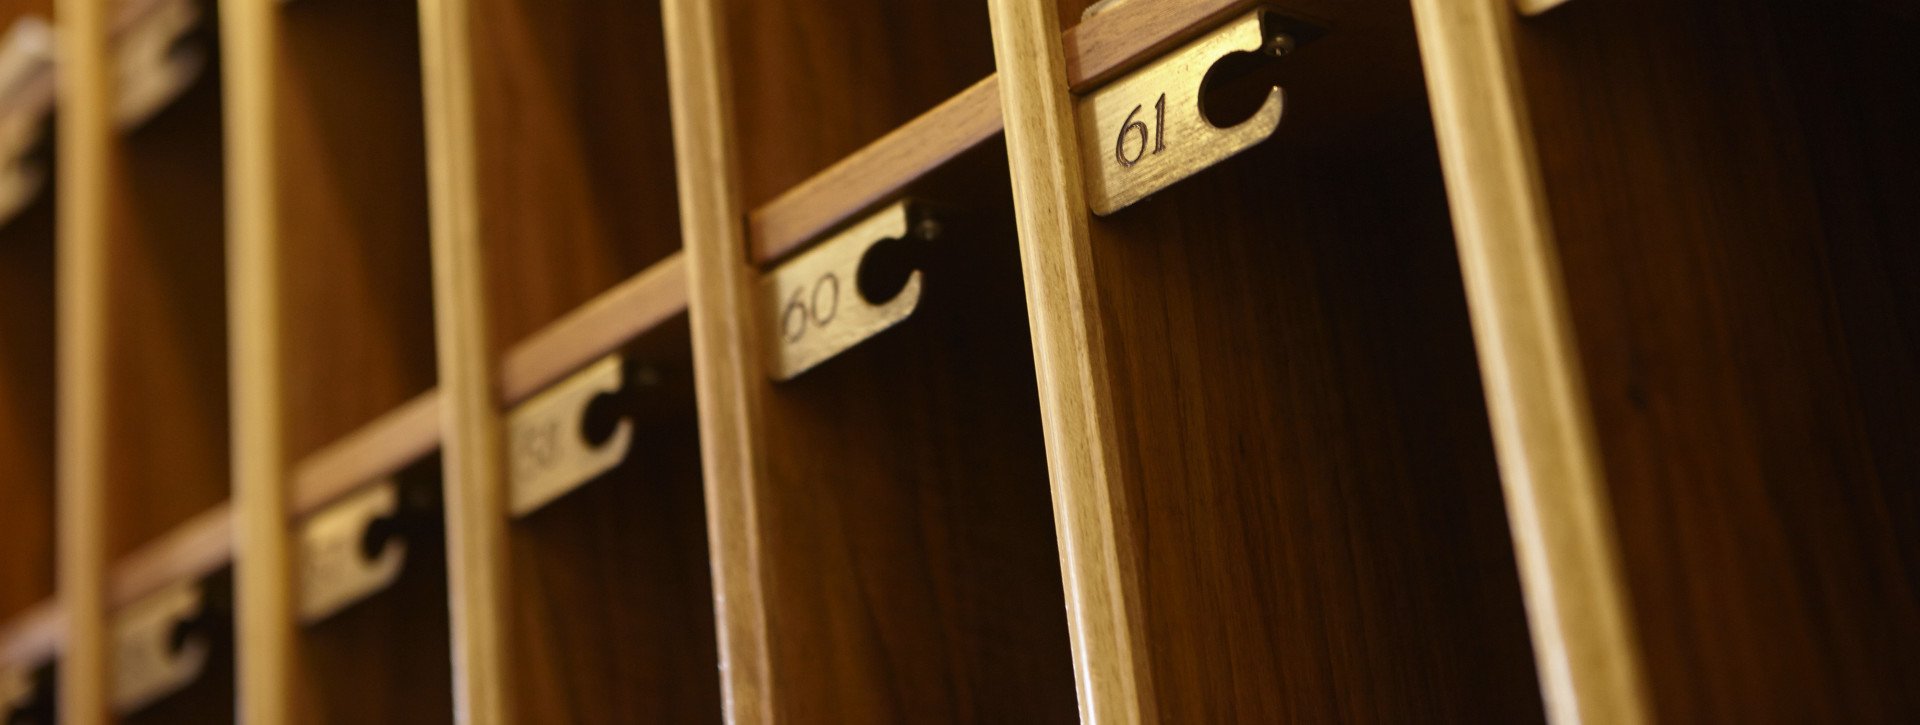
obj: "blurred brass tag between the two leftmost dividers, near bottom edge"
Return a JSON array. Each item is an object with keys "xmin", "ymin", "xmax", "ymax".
[{"xmin": 113, "ymin": 581, "xmax": 211, "ymax": 713}]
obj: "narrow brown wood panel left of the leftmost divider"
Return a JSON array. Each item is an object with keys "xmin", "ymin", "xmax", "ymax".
[{"xmin": 0, "ymin": 184, "xmax": 54, "ymax": 620}]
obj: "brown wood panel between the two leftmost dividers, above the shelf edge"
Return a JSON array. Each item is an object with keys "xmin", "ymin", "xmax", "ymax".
[{"xmin": 106, "ymin": 4, "xmax": 228, "ymax": 558}]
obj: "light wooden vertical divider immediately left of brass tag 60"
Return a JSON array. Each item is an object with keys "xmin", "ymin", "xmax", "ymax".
[{"xmin": 660, "ymin": 0, "xmax": 776, "ymax": 723}]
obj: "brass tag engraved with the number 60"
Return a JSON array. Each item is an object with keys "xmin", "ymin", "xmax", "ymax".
[{"xmin": 760, "ymin": 201, "xmax": 939, "ymax": 380}]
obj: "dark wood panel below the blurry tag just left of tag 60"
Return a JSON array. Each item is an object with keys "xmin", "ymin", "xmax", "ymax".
[{"xmin": 511, "ymin": 315, "xmax": 722, "ymax": 723}]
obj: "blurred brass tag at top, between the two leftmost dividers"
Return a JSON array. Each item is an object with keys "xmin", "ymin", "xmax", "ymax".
[{"xmin": 113, "ymin": 0, "xmax": 207, "ymax": 129}]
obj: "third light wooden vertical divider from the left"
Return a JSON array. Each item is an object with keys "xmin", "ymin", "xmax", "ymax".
[{"xmin": 420, "ymin": 0, "xmax": 513, "ymax": 725}]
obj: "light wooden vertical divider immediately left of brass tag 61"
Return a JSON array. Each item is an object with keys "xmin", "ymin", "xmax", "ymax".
[{"xmin": 989, "ymin": 0, "xmax": 1156, "ymax": 723}]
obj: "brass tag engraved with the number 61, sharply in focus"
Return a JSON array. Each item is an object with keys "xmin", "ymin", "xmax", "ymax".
[{"xmin": 1077, "ymin": 10, "xmax": 1292, "ymax": 215}]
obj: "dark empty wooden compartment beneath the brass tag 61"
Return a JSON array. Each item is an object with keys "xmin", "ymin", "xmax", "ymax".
[{"xmin": 1052, "ymin": 2, "xmax": 1544, "ymax": 723}]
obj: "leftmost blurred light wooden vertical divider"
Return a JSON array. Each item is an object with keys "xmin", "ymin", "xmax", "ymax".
[{"xmin": 54, "ymin": 0, "xmax": 113, "ymax": 725}]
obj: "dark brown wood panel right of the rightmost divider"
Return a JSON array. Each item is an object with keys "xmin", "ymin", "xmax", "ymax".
[{"xmin": 1517, "ymin": 0, "xmax": 1920, "ymax": 723}]
